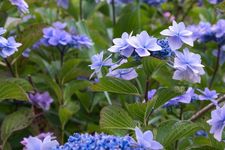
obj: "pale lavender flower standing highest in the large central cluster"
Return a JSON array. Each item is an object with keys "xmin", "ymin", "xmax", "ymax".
[{"xmin": 160, "ymin": 21, "xmax": 194, "ymax": 50}]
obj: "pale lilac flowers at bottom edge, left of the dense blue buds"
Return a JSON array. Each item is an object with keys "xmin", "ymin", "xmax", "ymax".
[{"xmin": 21, "ymin": 133, "xmax": 59, "ymax": 150}]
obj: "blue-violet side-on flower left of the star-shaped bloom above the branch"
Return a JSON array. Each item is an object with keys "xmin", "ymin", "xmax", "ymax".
[{"xmin": 163, "ymin": 87, "xmax": 195, "ymax": 107}]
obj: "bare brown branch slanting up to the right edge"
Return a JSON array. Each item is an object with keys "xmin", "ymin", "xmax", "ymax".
[{"xmin": 189, "ymin": 94, "xmax": 225, "ymax": 121}]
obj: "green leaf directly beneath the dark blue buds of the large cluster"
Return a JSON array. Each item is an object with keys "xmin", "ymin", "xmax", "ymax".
[{"xmin": 142, "ymin": 57, "xmax": 165, "ymax": 77}]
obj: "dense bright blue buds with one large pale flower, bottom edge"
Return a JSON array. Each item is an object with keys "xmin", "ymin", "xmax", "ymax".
[{"xmin": 53, "ymin": 127, "xmax": 163, "ymax": 150}]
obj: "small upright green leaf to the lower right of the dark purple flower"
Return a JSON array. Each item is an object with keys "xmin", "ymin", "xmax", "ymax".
[{"xmin": 59, "ymin": 101, "xmax": 80, "ymax": 127}]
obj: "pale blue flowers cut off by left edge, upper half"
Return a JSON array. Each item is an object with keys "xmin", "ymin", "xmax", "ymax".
[{"xmin": 0, "ymin": 28, "xmax": 22, "ymax": 58}]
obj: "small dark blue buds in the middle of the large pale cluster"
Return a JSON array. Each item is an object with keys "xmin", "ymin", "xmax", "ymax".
[{"xmin": 151, "ymin": 39, "xmax": 174, "ymax": 59}]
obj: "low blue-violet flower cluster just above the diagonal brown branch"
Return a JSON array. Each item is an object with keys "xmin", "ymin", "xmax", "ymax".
[{"xmin": 163, "ymin": 87, "xmax": 218, "ymax": 107}]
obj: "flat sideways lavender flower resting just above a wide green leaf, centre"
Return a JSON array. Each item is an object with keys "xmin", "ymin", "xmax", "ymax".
[{"xmin": 106, "ymin": 68, "xmax": 138, "ymax": 80}]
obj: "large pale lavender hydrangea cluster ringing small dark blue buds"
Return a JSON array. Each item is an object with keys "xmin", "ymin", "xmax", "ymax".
[{"xmin": 90, "ymin": 21, "xmax": 205, "ymax": 83}]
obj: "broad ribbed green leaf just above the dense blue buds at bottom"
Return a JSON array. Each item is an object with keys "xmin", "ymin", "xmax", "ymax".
[{"xmin": 100, "ymin": 106, "xmax": 136, "ymax": 130}]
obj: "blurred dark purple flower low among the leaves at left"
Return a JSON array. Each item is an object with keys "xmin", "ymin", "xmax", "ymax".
[{"xmin": 29, "ymin": 92, "xmax": 53, "ymax": 110}]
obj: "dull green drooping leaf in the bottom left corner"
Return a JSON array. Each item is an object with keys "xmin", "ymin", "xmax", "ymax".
[{"xmin": 1, "ymin": 109, "xmax": 34, "ymax": 148}]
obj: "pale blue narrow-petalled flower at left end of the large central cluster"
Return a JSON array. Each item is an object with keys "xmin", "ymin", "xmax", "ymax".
[{"xmin": 89, "ymin": 51, "xmax": 113, "ymax": 76}]
